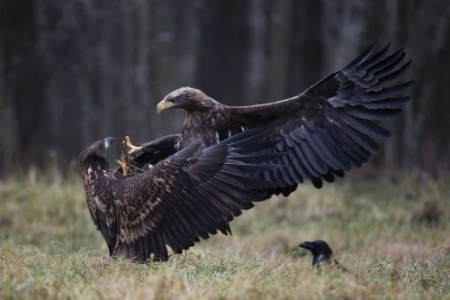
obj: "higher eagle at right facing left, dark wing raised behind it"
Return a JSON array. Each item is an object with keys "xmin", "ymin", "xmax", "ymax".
[{"xmin": 142, "ymin": 45, "xmax": 413, "ymax": 195}]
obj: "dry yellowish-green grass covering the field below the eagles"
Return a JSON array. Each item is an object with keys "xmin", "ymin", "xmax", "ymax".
[{"xmin": 0, "ymin": 172, "xmax": 450, "ymax": 299}]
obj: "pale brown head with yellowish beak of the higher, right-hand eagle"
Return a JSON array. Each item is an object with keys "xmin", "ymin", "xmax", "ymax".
[{"xmin": 156, "ymin": 87, "xmax": 215, "ymax": 114}]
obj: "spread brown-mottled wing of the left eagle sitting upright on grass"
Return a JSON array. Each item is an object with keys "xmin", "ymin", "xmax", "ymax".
[{"xmin": 114, "ymin": 131, "xmax": 280, "ymax": 260}]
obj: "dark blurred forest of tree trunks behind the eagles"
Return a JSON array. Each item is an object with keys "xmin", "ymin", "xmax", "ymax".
[{"xmin": 0, "ymin": 0, "xmax": 450, "ymax": 174}]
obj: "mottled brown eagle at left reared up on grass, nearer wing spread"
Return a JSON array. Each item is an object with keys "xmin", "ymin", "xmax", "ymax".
[{"xmin": 79, "ymin": 129, "xmax": 284, "ymax": 261}]
